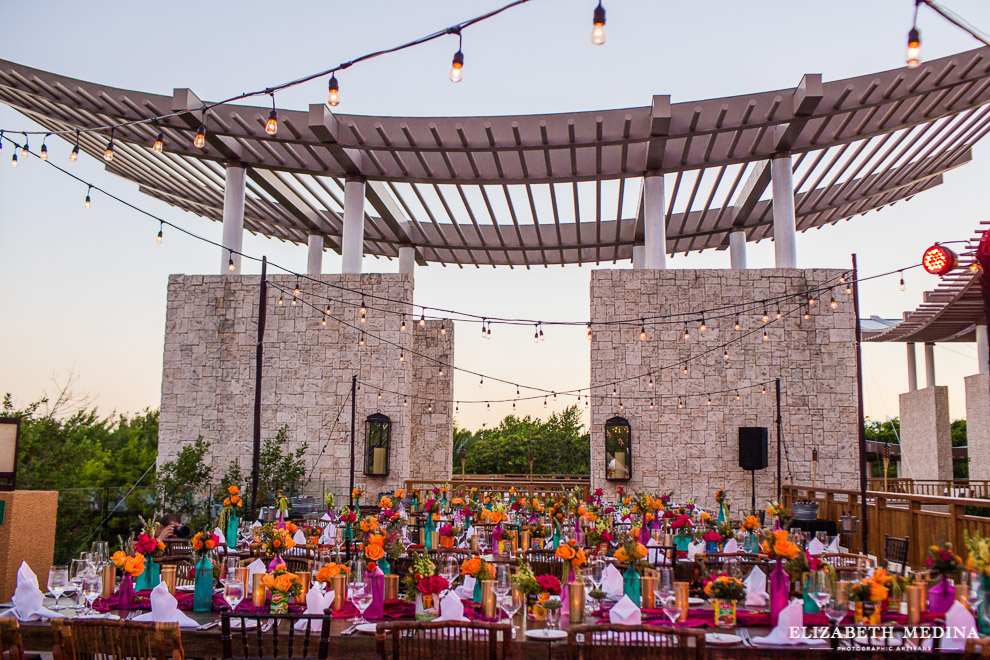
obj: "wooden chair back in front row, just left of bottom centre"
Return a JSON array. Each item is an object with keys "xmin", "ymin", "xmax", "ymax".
[{"xmin": 375, "ymin": 621, "xmax": 512, "ymax": 660}]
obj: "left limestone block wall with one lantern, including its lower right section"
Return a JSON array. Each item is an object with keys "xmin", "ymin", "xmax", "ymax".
[{"xmin": 159, "ymin": 274, "xmax": 453, "ymax": 495}]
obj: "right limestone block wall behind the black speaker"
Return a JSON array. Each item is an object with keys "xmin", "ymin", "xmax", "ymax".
[{"xmin": 590, "ymin": 269, "xmax": 859, "ymax": 511}]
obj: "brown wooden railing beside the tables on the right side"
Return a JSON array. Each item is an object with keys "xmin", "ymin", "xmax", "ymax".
[{"xmin": 782, "ymin": 480, "xmax": 990, "ymax": 570}]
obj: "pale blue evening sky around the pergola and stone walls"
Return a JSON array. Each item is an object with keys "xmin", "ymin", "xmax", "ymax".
[{"xmin": 0, "ymin": 0, "xmax": 990, "ymax": 428}]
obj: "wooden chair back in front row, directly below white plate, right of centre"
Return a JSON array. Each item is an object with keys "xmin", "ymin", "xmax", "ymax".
[{"xmin": 567, "ymin": 623, "xmax": 705, "ymax": 660}]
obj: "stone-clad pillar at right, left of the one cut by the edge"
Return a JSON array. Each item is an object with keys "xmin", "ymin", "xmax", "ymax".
[{"xmin": 900, "ymin": 385, "xmax": 952, "ymax": 479}]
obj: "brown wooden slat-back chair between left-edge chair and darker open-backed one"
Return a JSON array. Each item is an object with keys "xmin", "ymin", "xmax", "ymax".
[{"xmin": 52, "ymin": 619, "xmax": 185, "ymax": 660}]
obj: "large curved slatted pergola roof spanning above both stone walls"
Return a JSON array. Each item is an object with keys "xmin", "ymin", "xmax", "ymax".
[{"xmin": 0, "ymin": 48, "xmax": 990, "ymax": 267}]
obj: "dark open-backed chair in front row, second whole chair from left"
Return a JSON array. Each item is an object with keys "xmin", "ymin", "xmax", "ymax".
[{"xmin": 220, "ymin": 610, "xmax": 331, "ymax": 660}]
